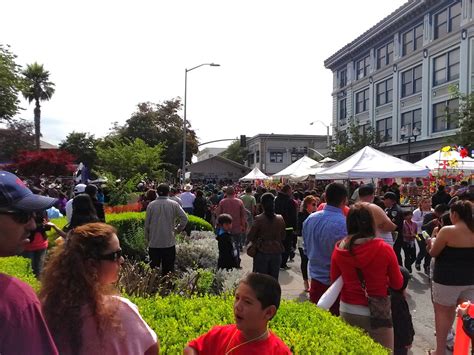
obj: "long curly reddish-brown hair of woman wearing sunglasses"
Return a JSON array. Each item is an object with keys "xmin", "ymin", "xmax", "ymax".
[{"xmin": 40, "ymin": 223, "xmax": 121, "ymax": 354}]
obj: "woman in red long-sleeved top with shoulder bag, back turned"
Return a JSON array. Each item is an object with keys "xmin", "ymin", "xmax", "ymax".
[{"xmin": 331, "ymin": 203, "xmax": 403, "ymax": 350}]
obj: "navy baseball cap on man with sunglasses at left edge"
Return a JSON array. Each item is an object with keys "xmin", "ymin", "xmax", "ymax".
[{"xmin": 0, "ymin": 170, "xmax": 57, "ymax": 212}]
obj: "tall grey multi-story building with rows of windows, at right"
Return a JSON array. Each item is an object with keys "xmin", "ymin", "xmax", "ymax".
[{"xmin": 324, "ymin": 0, "xmax": 474, "ymax": 162}]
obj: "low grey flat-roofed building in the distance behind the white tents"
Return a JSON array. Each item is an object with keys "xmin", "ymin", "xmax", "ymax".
[{"xmin": 247, "ymin": 133, "xmax": 331, "ymax": 175}]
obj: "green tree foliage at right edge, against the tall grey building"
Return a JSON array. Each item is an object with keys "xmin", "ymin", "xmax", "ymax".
[{"xmin": 446, "ymin": 89, "xmax": 474, "ymax": 152}]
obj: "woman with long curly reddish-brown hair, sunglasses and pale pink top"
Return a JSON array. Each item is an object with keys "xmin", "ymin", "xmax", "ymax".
[{"xmin": 40, "ymin": 223, "xmax": 159, "ymax": 354}]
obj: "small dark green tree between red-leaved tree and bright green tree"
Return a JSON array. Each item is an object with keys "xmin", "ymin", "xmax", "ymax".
[{"xmin": 59, "ymin": 132, "xmax": 98, "ymax": 169}]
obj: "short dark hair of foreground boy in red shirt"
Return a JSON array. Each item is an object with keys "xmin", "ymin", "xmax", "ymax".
[{"xmin": 240, "ymin": 272, "xmax": 281, "ymax": 309}]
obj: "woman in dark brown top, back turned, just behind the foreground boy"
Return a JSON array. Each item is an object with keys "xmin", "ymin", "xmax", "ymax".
[{"xmin": 247, "ymin": 193, "xmax": 285, "ymax": 280}]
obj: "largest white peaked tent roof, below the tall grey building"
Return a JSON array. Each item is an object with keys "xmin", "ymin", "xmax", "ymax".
[{"xmin": 316, "ymin": 146, "xmax": 429, "ymax": 180}]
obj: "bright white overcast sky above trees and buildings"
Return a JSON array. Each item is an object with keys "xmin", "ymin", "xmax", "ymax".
[{"xmin": 0, "ymin": 0, "xmax": 406, "ymax": 148}]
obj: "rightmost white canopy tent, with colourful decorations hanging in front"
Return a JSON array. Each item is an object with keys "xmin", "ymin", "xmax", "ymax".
[{"xmin": 415, "ymin": 150, "xmax": 474, "ymax": 173}]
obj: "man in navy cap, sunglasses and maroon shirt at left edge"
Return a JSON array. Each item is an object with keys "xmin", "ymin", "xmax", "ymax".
[{"xmin": 0, "ymin": 171, "xmax": 58, "ymax": 354}]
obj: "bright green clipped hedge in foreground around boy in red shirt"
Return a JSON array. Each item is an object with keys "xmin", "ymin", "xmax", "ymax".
[{"xmin": 0, "ymin": 257, "xmax": 389, "ymax": 354}]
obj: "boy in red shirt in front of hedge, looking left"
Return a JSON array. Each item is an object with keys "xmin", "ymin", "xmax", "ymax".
[{"xmin": 184, "ymin": 273, "xmax": 291, "ymax": 355}]
